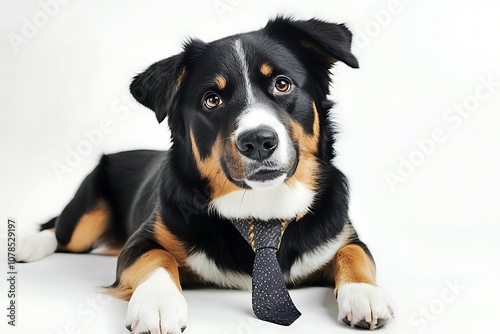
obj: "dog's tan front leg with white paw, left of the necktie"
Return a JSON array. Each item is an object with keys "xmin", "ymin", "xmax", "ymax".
[{"xmin": 109, "ymin": 229, "xmax": 187, "ymax": 334}]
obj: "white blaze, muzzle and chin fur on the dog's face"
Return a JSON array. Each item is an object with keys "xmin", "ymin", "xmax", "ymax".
[{"xmin": 210, "ymin": 39, "xmax": 315, "ymax": 220}]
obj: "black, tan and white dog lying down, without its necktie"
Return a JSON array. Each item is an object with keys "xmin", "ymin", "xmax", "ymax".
[{"xmin": 17, "ymin": 16, "xmax": 393, "ymax": 333}]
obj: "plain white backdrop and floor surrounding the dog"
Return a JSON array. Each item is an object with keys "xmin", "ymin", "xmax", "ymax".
[{"xmin": 0, "ymin": 0, "xmax": 500, "ymax": 334}]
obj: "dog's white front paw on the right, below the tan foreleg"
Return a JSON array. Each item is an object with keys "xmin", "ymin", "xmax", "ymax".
[{"xmin": 337, "ymin": 283, "xmax": 393, "ymax": 330}]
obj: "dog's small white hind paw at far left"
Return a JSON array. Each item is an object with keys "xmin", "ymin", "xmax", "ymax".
[{"xmin": 16, "ymin": 230, "xmax": 57, "ymax": 262}]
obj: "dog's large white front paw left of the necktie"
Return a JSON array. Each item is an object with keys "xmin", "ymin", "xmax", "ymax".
[{"xmin": 125, "ymin": 268, "xmax": 187, "ymax": 334}]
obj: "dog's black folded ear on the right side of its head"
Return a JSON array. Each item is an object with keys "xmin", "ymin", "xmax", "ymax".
[{"xmin": 264, "ymin": 17, "xmax": 359, "ymax": 68}]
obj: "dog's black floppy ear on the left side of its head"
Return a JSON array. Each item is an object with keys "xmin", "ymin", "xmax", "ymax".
[{"xmin": 130, "ymin": 40, "xmax": 205, "ymax": 134}]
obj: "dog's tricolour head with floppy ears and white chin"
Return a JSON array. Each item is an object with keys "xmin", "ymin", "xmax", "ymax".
[{"xmin": 130, "ymin": 17, "xmax": 358, "ymax": 219}]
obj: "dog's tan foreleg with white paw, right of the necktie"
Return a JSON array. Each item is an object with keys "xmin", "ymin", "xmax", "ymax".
[{"xmin": 334, "ymin": 242, "xmax": 393, "ymax": 329}]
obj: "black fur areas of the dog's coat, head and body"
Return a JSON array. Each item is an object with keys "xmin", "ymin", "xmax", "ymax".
[{"xmin": 47, "ymin": 17, "xmax": 367, "ymax": 286}]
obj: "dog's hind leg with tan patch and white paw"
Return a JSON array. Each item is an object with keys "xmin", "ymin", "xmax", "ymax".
[{"xmin": 16, "ymin": 165, "xmax": 111, "ymax": 262}]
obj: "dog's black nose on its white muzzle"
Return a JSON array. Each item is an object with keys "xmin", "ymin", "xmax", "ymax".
[{"xmin": 236, "ymin": 126, "xmax": 278, "ymax": 161}]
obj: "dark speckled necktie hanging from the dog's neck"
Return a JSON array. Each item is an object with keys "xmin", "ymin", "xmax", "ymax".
[{"xmin": 232, "ymin": 219, "xmax": 301, "ymax": 326}]
